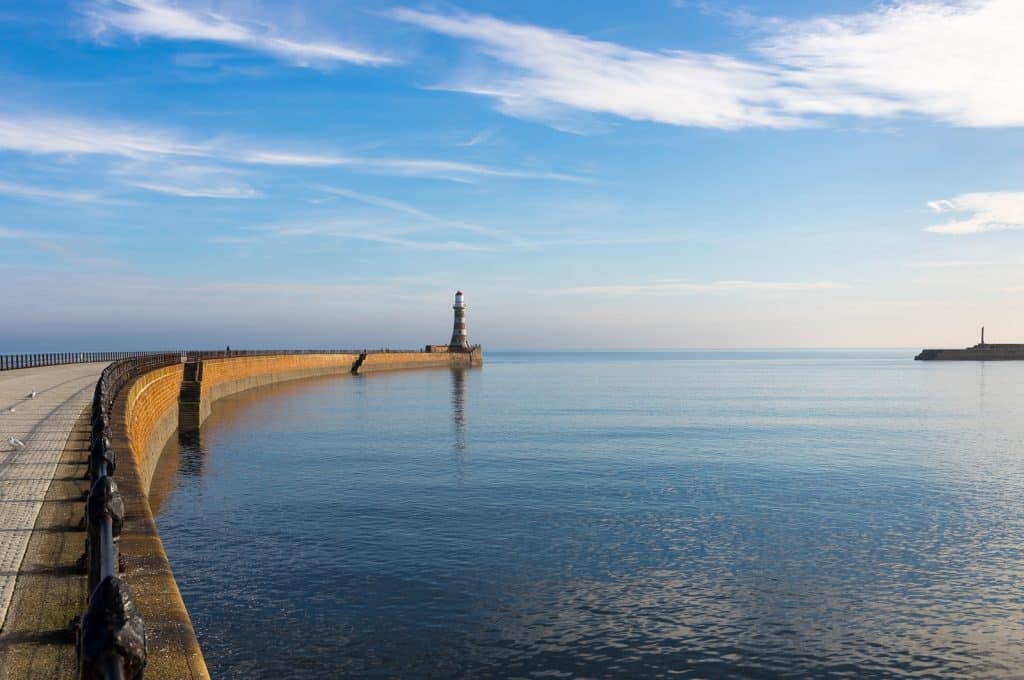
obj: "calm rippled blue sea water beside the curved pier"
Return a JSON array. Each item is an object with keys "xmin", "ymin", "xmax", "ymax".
[{"xmin": 154, "ymin": 351, "xmax": 1024, "ymax": 678}]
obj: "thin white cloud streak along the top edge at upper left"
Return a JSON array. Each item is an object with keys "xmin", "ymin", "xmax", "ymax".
[{"xmin": 85, "ymin": 0, "xmax": 394, "ymax": 67}]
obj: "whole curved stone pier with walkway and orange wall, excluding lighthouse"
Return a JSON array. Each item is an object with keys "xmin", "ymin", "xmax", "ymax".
[{"xmin": 0, "ymin": 345, "xmax": 483, "ymax": 680}]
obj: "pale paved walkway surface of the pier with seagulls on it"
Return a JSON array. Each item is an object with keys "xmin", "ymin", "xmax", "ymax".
[{"xmin": 0, "ymin": 363, "xmax": 106, "ymax": 630}]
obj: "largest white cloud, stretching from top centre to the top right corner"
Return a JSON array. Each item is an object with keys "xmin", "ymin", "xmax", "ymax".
[{"xmin": 391, "ymin": 0, "xmax": 1024, "ymax": 129}]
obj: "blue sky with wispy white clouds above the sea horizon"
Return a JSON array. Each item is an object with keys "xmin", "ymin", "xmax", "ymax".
[{"xmin": 0, "ymin": 0, "xmax": 1024, "ymax": 352}]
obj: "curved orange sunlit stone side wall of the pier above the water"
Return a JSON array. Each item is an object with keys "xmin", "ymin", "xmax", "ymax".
[{"xmin": 112, "ymin": 348, "xmax": 483, "ymax": 680}]
